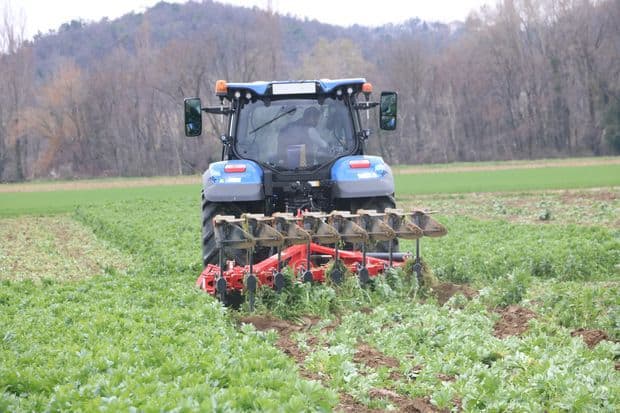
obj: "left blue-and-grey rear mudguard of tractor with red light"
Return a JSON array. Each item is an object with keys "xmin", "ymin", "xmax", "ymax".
[{"xmin": 202, "ymin": 159, "xmax": 265, "ymax": 202}]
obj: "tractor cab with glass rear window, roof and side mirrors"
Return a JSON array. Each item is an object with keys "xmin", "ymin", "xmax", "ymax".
[{"xmin": 185, "ymin": 79, "xmax": 396, "ymax": 172}]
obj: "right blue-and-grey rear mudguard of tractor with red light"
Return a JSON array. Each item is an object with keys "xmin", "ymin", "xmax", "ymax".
[{"xmin": 331, "ymin": 155, "xmax": 394, "ymax": 198}]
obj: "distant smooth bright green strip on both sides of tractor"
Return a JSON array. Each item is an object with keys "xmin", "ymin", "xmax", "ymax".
[{"xmin": 0, "ymin": 164, "xmax": 620, "ymax": 216}]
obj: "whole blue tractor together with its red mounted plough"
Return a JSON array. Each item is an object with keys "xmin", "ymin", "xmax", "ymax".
[{"xmin": 184, "ymin": 78, "xmax": 446, "ymax": 308}]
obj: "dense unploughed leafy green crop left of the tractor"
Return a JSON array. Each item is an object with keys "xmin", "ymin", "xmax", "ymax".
[{"xmin": 0, "ymin": 199, "xmax": 336, "ymax": 411}]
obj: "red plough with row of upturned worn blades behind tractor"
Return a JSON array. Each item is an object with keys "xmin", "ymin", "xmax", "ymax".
[{"xmin": 196, "ymin": 208, "xmax": 447, "ymax": 310}]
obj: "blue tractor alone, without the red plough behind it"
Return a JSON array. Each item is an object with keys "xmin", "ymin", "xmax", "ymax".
[{"xmin": 184, "ymin": 78, "xmax": 397, "ymax": 266}]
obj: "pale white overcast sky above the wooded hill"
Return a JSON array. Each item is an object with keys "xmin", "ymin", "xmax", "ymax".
[{"xmin": 0, "ymin": 0, "xmax": 495, "ymax": 37}]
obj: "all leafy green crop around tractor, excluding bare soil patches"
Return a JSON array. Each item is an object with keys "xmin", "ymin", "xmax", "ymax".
[{"xmin": 0, "ymin": 179, "xmax": 620, "ymax": 411}]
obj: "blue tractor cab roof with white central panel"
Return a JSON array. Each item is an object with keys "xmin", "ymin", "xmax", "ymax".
[{"xmin": 216, "ymin": 78, "xmax": 366, "ymax": 98}]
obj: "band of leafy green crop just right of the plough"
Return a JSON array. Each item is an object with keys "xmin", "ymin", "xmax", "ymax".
[{"xmin": 401, "ymin": 217, "xmax": 620, "ymax": 285}]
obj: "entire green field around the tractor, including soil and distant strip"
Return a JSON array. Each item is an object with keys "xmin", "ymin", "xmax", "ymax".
[{"xmin": 0, "ymin": 157, "xmax": 620, "ymax": 412}]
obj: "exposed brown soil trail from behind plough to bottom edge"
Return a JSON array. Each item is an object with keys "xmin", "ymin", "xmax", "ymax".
[{"xmin": 239, "ymin": 316, "xmax": 452, "ymax": 413}]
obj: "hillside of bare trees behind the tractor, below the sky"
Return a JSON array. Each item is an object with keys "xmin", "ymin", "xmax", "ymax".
[{"xmin": 0, "ymin": 0, "xmax": 620, "ymax": 181}]
